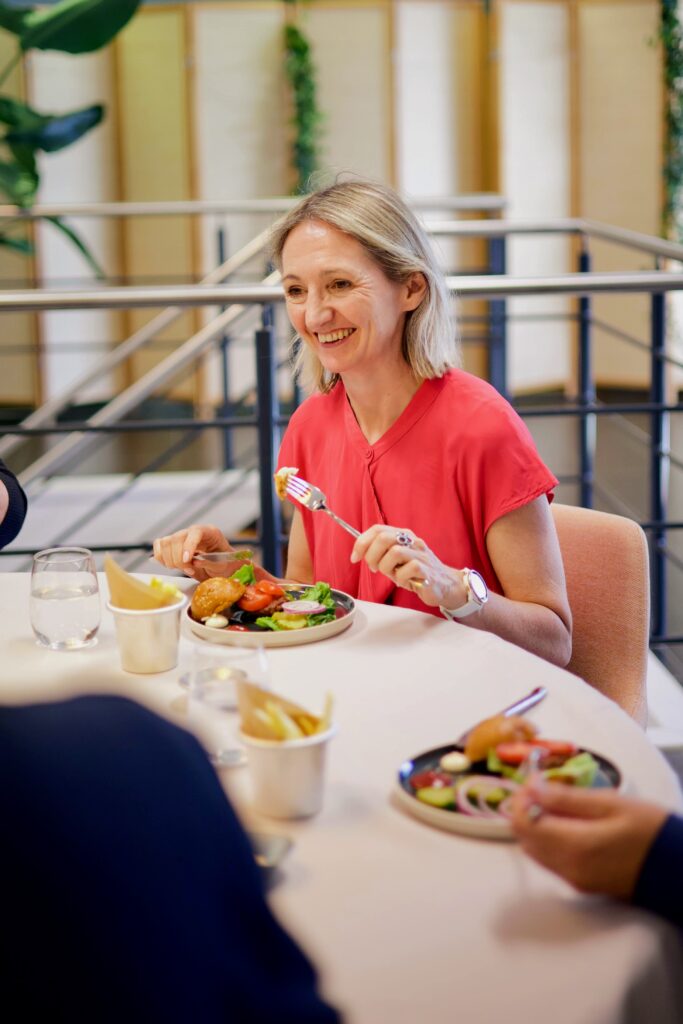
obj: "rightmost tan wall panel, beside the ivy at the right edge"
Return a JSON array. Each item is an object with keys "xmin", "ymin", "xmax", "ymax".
[{"xmin": 578, "ymin": 0, "xmax": 664, "ymax": 387}]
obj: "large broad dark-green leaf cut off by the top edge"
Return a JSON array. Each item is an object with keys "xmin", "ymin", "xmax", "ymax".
[{"xmin": 19, "ymin": 0, "xmax": 141, "ymax": 53}]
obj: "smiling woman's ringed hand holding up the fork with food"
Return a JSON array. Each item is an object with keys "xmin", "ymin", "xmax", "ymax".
[{"xmin": 351, "ymin": 523, "xmax": 467, "ymax": 608}]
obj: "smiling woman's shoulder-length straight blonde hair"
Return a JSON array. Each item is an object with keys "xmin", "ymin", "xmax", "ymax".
[{"xmin": 270, "ymin": 180, "xmax": 460, "ymax": 392}]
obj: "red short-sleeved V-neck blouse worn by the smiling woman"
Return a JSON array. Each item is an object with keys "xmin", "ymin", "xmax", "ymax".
[{"xmin": 279, "ymin": 370, "xmax": 557, "ymax": 614}]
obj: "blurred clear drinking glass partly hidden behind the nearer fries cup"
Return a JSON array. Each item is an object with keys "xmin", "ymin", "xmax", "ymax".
[{"xmin": 180, "ymin": 642, "xmax": 270, "ymax": 768}]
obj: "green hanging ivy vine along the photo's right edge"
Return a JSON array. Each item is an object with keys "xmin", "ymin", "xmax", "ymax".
[{"xmin": 660, "ymin": 0, "xmax": 683, "ymax": 238}]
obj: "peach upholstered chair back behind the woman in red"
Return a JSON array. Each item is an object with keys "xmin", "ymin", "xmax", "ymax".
[{"xmin": 551, "ymin": 502, "xmax": 650, "ymax": 726}]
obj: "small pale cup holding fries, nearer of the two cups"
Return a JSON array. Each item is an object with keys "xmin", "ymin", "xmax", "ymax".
[{"xmin": 240, "ymin": 725, "xmax": 337, "ymax": 818}]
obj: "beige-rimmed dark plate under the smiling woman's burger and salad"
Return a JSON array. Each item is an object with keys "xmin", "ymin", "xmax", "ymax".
[{"xmin": 185, "ymin": 587, "xmax": 355, "ymax": 647}]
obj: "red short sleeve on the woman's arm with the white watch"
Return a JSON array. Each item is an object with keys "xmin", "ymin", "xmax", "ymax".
[{"xmin": 456, "ymin": 390, "xmax": 558, "ymax": 536}]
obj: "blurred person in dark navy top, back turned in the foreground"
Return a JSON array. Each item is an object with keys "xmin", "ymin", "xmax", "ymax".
[{"xmin": 0, "ymin": 696, "xmax": 339, "ymax": 1024}]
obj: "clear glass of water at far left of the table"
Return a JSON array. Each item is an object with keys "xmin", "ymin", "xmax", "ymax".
[{"xmin": 31, "ymin": 548, "xmax": 100, "ymax": 650}]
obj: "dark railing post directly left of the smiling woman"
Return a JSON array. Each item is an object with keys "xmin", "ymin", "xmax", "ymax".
[{"xmin": 256, "ymin": 306, "xmax": 282, "ymax": 575}]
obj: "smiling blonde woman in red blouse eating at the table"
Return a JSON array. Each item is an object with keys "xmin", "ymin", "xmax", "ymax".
[{"xmin": 155, "ymin": 181, "xmax": 571, "ymax": 665}]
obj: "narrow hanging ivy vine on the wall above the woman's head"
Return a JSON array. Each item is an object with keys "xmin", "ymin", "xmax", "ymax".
[{"xmin": 285, "ymin": 0, "xmax": 323, "ymax": 194}]
